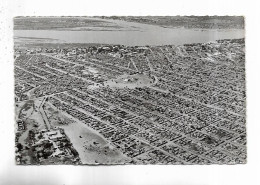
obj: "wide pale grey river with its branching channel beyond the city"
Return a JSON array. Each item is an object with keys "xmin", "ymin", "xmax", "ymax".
[{"xmin": 14, "ymin": 18, "xmax": 245, "ymax": 46}]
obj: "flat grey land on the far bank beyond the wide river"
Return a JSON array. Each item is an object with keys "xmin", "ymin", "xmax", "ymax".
[{"xmin": 14, "ymin": 16, "xmax": 244, "ymax": 30}]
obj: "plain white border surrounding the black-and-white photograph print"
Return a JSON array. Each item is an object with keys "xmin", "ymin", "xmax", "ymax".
[{"xmin": 0, "ymin": 0, "xmax": 260, "ymax": 185}]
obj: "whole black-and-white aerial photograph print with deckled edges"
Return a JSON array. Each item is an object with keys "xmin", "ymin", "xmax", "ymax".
[{"xmin": 13, "ymin": 16, "xmax": 247, "ymax": 165}]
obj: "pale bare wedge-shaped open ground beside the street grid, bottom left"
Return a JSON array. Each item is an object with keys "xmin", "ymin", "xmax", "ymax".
[{"xmin": 45, "ymin": 104, "xmax": 131, "ymax": 164}]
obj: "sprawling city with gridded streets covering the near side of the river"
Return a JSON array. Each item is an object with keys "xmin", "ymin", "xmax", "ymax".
[{"xmin": 14, "ymin": 36, "xmax": 246, "ymax": 164}]
